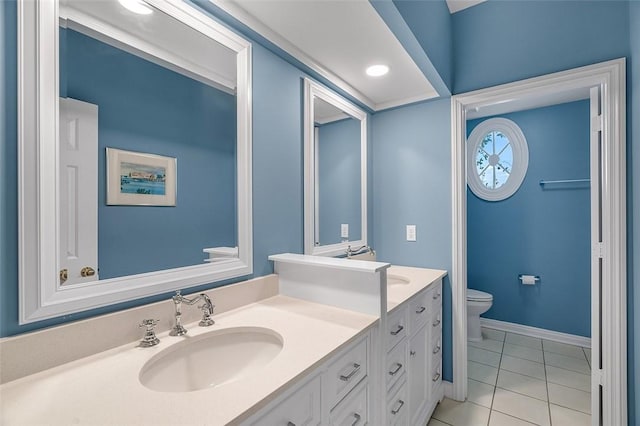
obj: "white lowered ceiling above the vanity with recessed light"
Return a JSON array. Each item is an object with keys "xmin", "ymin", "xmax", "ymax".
[{"xmin": 212, "ymin": 0, "xmax": 438, "ymax": 110}]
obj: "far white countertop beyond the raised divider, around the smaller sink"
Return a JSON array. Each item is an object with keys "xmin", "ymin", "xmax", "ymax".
[{"xmin": 387, "ymin": 265, "xmax": 447, "ymax": 312}]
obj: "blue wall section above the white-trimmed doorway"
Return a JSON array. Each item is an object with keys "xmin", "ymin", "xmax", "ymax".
[{"xmin": 452, "ymin": 0, "xmax": 629, "ymax": 93}]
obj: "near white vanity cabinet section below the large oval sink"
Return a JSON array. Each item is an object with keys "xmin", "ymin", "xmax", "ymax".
[{"xmin": 242, "ymin": 333, "xmax": 371, "ymax": 426}]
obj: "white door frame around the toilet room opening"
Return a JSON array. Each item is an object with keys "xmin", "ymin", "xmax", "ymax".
[{"xmin": 450, "ymin": 59, "xmax": 627, "ymax": 425}]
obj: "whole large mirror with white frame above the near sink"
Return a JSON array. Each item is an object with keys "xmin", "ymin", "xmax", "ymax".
[{"xmin": 18, "ymin": 0, "xmax": 253, "ymax": 324}]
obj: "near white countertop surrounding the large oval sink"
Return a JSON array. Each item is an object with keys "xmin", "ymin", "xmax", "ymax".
[{"xmin": 0, "ymin": 294, "xmax": 378, "ymax": 425}]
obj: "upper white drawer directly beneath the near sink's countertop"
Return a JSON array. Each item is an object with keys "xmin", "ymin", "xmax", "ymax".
[{"xmin": 323, "ymin": 337, "xmax": 369, "ymax": 407}]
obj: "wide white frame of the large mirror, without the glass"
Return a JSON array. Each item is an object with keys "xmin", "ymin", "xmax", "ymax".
[{"xmin": 18, "ymin": 0, "xmax": 253, "ymax": 324}]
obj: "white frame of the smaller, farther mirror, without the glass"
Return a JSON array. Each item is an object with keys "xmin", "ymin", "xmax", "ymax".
[{"xmin": 304, "ymin": 78, "xmax": 367, "ymax": 256}]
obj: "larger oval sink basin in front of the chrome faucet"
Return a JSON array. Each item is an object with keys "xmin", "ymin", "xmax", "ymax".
[{"xmin": 139, "ymin": 327, "xmax": 283, "ymax": 392}]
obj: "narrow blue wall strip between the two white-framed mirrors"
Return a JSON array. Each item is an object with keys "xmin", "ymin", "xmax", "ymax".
[{"xmin": 253, "ymin": 44, "xmax": 304, "ymax": 276}]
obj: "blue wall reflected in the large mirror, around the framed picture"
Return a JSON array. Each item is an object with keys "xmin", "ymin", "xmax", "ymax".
[{"xmin": 60, "ymin": 29, "xmax": 237, "ymax": 279}]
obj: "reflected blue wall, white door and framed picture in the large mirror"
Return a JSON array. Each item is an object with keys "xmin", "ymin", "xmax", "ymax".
[{"xmin": 59, "ymin": 10, "xmax": 237, "ymax": 285}]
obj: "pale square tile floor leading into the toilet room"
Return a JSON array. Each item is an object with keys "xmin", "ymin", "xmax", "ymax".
[{"xmin": 428, "ymin": 328, "xmax": 591, "ymax": 426}]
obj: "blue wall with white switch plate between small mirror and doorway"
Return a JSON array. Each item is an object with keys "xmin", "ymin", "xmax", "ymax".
[{"xmin": 371, "ymin": 99, "xmax": 453, "ymax": 380}]
